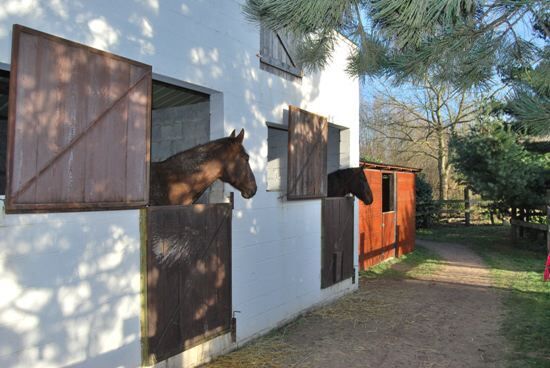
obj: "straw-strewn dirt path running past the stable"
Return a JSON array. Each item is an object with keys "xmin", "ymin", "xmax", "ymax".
[{"xmin": 209, "ymin": 241, "xmax": 506, "ymax": 368}]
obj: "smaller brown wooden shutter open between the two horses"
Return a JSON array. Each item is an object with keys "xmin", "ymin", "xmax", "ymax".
[{"xmin": 287, "ymin": 106, "xmax": 328, "ymax": 199}]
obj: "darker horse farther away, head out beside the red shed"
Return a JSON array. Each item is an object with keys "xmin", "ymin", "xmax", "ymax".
[{"xmin": 327, "ymin": 167, "xmax": 372, "ymax": 204}]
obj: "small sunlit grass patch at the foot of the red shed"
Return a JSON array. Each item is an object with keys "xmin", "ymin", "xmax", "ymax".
[{"xmin": 359, "ymin": 246, "xmax": 448, "ymax": 279}]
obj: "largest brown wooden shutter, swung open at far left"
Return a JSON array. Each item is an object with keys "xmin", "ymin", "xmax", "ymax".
[{"xmin": 6, "ymin": 25, "xmax": 152, "ymax": 212}]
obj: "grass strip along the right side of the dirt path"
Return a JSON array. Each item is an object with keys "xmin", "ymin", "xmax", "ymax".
[{"xmin": 417, "ymin": 226, "xmax": 550, "ymax": 367}]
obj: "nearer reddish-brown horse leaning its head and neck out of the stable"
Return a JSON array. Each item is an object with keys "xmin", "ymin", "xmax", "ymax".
[{"xmin": 149, "ymin": 129, "xmax": 257, "ymax": 205}]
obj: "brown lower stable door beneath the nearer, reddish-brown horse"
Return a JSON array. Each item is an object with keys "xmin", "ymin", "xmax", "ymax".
[{"xmin": 145, "ymin": 203, "xmax": 232, "ymax": 362}]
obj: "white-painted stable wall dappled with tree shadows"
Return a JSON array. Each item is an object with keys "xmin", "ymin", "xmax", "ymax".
[{"xmin": 0, "ymin": 0, "xmax": 359, "ymax": 367}]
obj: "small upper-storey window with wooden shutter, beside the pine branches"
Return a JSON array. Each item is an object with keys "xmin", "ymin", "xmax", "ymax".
[{"xmin": 260, "ymin": 26, "xmax": 303, "ymax": 80}]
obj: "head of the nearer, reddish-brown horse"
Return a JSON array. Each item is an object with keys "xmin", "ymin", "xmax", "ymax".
[{"xmin": 221, "ymin": 129, "xmax": 257, "ymax": 199}]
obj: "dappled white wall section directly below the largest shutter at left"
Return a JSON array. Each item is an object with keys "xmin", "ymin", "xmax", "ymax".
[{"xmin": 0, "ymin": 210, "xmax": 140, "ymax": 367}]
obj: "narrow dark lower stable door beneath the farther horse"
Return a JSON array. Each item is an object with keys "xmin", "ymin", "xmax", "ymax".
[{"xmin": 321, "ymin": 197, "xmax": 354, "ymax": 288}]
